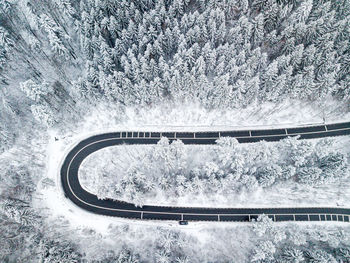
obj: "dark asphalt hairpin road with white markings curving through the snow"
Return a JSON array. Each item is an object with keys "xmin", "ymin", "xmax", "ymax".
[{"xmin": 61, "ymin": 122, "xmax": 350, "ymax": 222}]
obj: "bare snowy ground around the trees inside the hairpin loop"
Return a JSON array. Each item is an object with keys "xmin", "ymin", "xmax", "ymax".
[{"xmin": 79, "ymin": 136, "xmax": 350, "ymax": 207}]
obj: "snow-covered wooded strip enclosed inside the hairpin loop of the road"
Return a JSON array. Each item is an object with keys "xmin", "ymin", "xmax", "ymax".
[{"xmin": 79, "ymin": 137, "xmax": 350, "ymax": 207}]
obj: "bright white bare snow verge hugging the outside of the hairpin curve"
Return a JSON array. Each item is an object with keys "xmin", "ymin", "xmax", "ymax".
[{"xmin": 33, "ymin": 131, "xmax": 241, "ymax": 236}]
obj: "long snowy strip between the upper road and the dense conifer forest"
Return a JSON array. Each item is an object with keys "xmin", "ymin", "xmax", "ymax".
[{"xmin": 57, "ymin": 98, "xmax": 350, "ymax": 138}]
